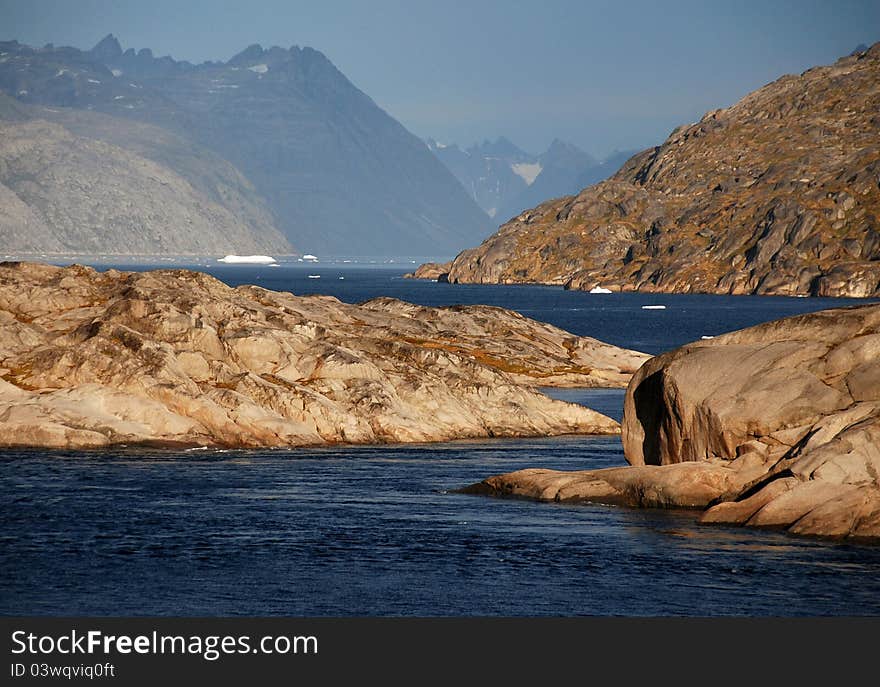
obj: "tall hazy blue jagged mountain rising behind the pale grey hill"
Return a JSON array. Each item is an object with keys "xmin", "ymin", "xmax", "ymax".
[{"xmin": 0, "ymin": 35, "xmax": 491, "ymax": 255}]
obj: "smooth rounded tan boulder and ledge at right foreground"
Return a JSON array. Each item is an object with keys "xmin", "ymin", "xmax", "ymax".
[{"xmin": 465, "ymin": 305, "xmax": 880, "ymax": 542}]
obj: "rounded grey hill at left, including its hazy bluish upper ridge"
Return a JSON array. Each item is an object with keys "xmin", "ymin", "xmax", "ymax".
[{"xmin": 0, "ymin": 93, "xmax": 291, "ymax": 254}]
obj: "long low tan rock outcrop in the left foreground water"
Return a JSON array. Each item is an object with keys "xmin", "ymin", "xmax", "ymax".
[{"xmin": 0, "ymin": 263, "xmax": 648, "ymax": 447}]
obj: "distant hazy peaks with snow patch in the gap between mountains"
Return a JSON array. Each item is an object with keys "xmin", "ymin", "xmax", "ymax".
[{"xmin": 425, "ymin": 136, "xmax": 633, "ymax": 226}]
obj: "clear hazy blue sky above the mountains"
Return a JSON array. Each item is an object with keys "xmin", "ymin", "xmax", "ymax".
[{"xmin": 0, "ymin": 0, "xmax": 880, "ymax": 157}]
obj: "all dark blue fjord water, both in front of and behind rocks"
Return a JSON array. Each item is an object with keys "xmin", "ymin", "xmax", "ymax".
[{"xmin": 0, "ymin": 265, "xmax": 880, "ymax": 616}]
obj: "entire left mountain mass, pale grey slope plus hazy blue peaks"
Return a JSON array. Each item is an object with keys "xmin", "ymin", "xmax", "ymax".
[{"xmin": 0, "ymin": 35, "xmax": 492, "ymax": 255}]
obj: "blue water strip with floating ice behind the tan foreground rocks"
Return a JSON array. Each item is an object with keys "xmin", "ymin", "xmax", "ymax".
[{"xmin": 102, "ymin": 263, "xmax": 870, "ymax": 354}]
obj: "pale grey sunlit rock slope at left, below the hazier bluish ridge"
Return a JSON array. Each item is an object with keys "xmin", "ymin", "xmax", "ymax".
[{"xmin": 0, "ymin": 118, "xmax": 291, "ymax": 255}]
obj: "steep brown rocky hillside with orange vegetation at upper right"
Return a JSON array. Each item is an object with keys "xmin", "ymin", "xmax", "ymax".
[{"xmin": 415, "ymin": 43, "xmax": 880, "ymax": 297}]
